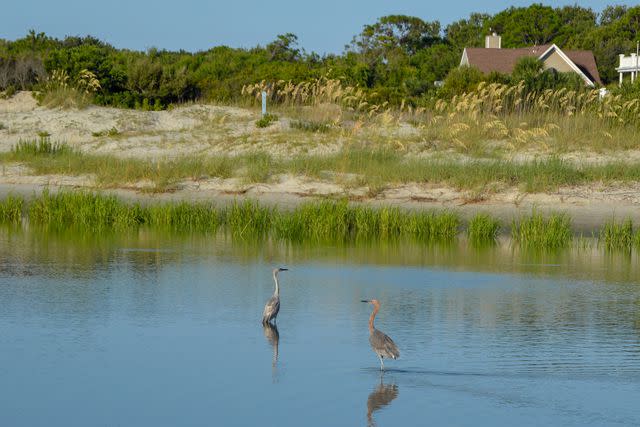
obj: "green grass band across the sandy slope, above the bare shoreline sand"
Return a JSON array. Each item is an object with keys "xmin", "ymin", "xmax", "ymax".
[{"xmin": 0, "ymin": 140, "xmax": 640, "ymax": 196}]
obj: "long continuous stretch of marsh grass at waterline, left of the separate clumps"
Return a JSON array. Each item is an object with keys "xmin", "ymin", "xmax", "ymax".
[{"xmin": 11, "ymin": 191, "xmax": 460, "ymax": 242}]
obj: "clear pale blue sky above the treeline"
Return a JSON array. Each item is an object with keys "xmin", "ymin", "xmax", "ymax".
[{"xmin": 0, "ymin": 0, "xmax": 638, "ymax": 53}]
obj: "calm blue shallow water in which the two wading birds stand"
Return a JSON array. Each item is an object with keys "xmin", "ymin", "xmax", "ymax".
[{"xmin": 0, "ymin": 230, "xmax": 640, "ymax": 426}]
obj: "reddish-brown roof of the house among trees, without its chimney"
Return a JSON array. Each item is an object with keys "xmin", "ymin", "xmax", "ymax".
[{"xmin": 465, "ymin": 44, "xmax": 602, "ymax": 84}]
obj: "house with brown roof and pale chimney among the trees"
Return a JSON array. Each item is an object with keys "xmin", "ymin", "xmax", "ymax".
[{"xmin": 460, "ymin": 33, "xmax": 602, "ymax": 87}]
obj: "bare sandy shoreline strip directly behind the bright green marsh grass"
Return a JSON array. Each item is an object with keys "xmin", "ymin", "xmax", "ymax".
[{"xmin": 0, "ymin": 180, "xmax": 640, "ymax": 237}]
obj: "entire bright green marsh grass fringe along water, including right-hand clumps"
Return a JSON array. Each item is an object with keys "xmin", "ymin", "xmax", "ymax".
[{"xmin": 0, "ymin": 192, "xmax": 640, "ymax": 250}]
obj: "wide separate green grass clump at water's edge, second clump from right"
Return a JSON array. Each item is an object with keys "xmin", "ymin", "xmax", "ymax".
[{"xmin": 511, "ymin": 212, "xmax": 573, "ymax": 249}]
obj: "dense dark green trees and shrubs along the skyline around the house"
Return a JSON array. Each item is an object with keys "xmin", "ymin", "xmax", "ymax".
[{"xmin": 0, "ymin": 4, "xmax": 640, "ymax": 110}]
